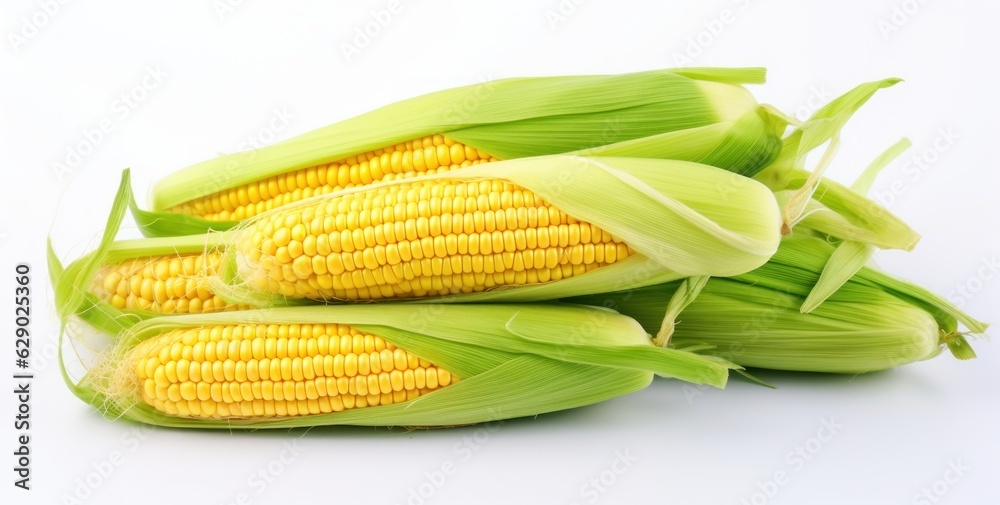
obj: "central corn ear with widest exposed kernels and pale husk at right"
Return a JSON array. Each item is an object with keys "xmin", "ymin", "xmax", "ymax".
[{"xmin": 212, "ymin": 156, "xmax": 780, "ymax": 305}]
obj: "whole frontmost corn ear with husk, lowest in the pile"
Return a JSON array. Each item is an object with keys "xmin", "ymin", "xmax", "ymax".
[{"xmin": 60, "ymin": 304, "xmax": 731, "ymax": 429}]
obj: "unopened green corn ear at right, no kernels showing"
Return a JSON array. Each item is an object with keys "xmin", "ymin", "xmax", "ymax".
[{"xmin": 571, "ymin": 235, "xmax": 986, "ymax": 373}]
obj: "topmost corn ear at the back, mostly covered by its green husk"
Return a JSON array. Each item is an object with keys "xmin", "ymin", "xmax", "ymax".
[{"xmin": 134, "ymin": 69, "xmax": 786, "ymax": 235}]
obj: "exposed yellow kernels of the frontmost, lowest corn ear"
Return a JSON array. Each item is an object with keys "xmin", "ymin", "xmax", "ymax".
[{"xmin": 128, "ymin": 324, "xmax": 458, "ymax": 419}]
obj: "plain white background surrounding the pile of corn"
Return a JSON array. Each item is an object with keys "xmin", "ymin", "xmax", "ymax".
[{"xmin": 0, "ymin": 0, "xmax": 1000, "ymax": 504}]
